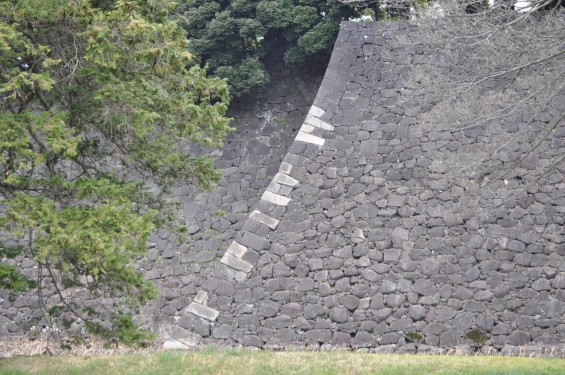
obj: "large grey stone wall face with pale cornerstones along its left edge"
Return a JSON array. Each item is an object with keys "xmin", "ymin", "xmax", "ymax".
[{"xmin": 166, "ymin": 22, "xmax": 565, "ymax": 355}]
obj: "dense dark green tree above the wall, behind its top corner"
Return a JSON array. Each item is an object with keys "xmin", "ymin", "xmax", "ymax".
[{"xmin": 177, "ymin": 0, "xmax": 379, "ymax": 97}]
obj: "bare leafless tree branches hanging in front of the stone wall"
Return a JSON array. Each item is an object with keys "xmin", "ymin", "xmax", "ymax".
[{"xmin": 388, "ymin": 0, "xmax": 565, "ymax": 205}]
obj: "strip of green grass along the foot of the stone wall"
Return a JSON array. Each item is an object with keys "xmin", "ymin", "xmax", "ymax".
[{"xmin": 0, "ymin": 349, "xmax": 565, "ymax": 375}]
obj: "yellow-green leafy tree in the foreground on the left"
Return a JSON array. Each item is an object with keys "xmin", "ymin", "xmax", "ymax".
[{"xmin": 0, "ymin": 0, "xmax": 231, "ymax": 342}]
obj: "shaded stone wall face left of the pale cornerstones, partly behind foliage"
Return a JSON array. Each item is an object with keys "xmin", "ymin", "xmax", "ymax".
[{"xmin": 0, "ymin": 50, "xmax": 329, "ymax": 337}]
